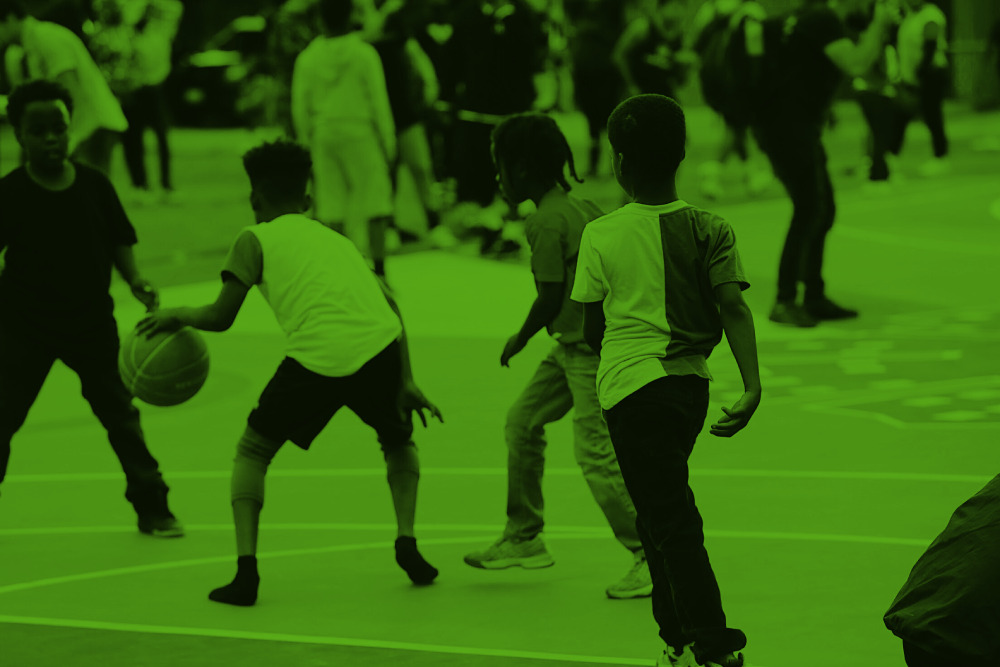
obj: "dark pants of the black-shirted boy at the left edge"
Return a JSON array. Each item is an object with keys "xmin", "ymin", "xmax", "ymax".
[{"xmin": 0, "ymin": 309, "xmax": 169, "ymax": 517}]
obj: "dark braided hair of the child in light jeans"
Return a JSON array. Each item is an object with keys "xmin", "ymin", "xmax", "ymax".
[{"xmin": 492, "ymin": 113, "xmax": 583, "ymax": 192}]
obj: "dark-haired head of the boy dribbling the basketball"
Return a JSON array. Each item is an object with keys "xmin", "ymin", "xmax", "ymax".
[{"xmin": 243, "ymin": 139, "xmax": 312, "ymax": 204}]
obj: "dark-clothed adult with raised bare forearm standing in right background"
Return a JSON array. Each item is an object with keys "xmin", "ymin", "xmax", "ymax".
[{"xmin": 752, "ymin": 0, "xmax": 898, "ymax": 327}]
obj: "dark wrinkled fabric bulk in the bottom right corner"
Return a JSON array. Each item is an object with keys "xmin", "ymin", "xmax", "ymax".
[{"xmin": 883, "ymin": 475, "xmax": 1000, "ymax": 667}]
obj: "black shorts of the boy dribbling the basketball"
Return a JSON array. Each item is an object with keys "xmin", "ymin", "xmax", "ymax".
[{"xmin": 247, "ymin": 341, "xmax": 413, "ymax": 451}]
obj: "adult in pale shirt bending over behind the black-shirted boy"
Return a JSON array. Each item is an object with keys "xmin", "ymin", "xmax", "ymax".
[{"xmin": 0, "ymin": 0, "xmax": 128, "ymax": 175}]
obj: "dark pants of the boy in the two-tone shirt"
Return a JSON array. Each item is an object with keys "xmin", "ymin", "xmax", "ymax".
[{"xmin": 604, "ymin": 375, "xmax": 746, "ymax": 659}]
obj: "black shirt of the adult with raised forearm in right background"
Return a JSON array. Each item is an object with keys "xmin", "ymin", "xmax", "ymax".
[{"xmin": 761, "ymin": 4, "xmax": 847, "ymax": 126}]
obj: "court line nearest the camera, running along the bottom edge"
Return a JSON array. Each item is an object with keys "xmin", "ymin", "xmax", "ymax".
[{"xmin": 0, "ymin": 615, "xmax": 704, "ymax": 667}]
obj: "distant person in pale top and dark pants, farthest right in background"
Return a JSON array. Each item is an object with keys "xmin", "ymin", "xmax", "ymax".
[{"xmin": 896, "ymin": 0, "xmax": 950, "ymax": 176}]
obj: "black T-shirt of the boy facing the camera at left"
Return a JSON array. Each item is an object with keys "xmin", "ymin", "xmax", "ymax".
[{"xmin": 0, "ymin": 162, "xmax": 136, "ymax": 322}]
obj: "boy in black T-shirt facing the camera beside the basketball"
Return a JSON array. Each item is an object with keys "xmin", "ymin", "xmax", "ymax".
[{"xmin": 0, "ymin": 80, "xmax": 184, "ymax": 537}]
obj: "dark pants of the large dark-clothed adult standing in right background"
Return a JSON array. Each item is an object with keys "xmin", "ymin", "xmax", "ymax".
[{"xmin": 753, "ymin": 122, "xmax": 837, "ymax": 301}]
